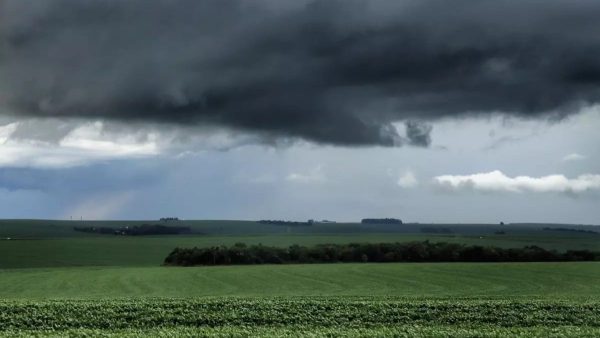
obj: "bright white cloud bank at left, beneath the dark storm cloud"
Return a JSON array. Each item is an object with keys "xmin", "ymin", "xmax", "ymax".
[{"xmin": 0, "ymin": 119, "xmax": 279, "ymax": 168}]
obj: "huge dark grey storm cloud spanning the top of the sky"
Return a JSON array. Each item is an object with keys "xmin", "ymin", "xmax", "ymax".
[{"xmin": 0, "ymin": 0, "xmax": 600, "ymax": 145}]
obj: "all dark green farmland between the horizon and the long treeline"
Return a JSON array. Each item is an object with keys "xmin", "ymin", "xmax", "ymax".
[{"xmin": 0, "ymin": 220, "xmax": 600, "ymax": 269}]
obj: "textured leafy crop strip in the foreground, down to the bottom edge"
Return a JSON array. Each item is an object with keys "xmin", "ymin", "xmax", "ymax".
[{"xmin": 0, "ymin": 297, "xmax": 600, "ymax": 337}]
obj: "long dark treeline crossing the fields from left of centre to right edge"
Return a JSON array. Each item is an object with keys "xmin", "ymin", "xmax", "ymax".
[{"xmin": 164, "ymin": 241, "xmax": 600, "ymax": 266}]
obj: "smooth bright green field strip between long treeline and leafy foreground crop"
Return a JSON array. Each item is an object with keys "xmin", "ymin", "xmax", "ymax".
[{"xmin": 0, "ymin": 262, "xmax": 600, "ymax": 299}]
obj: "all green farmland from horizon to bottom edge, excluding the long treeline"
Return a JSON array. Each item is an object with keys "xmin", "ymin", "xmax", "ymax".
[{"xmin": 0, "ymin": 221, "xmax": 600, "ymax": 337}]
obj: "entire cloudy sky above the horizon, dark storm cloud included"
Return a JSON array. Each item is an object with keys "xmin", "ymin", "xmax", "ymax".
[{"xmin": 0, "ymin": 0, "xmax": 600, "ymax": 224}]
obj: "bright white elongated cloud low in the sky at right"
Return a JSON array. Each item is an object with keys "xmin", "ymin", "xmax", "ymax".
[{"xmin": 434, "ymin": 170, "xmax": 600, "ymax": 193}]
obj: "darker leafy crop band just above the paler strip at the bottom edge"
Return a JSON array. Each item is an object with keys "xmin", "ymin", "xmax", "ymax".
[{"xmin": 0, "ymin": 298, "xmax": 600, "ymax": 331}]
